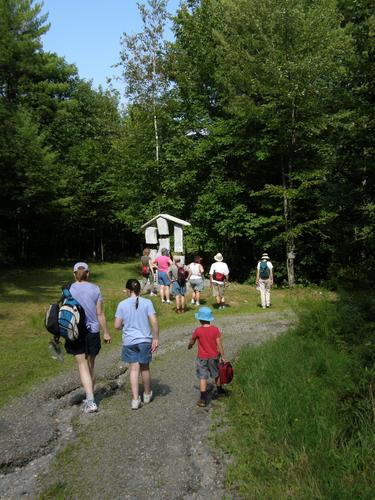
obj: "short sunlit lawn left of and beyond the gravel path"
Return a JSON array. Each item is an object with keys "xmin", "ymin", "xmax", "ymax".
[{"xmin": 0, "ymin": 260, "xmax": 306, "ymax": 406}]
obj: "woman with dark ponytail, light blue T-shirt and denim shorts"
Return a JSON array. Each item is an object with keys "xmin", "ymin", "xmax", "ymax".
[{"xmin": 115, "ymin": 279, "xmax": 159, "ymax": 410}]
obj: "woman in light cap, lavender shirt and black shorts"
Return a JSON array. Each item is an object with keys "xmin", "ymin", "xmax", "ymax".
[{"xmin": 65, "ymin": 262, "xmax": 112, "ymax": 413}]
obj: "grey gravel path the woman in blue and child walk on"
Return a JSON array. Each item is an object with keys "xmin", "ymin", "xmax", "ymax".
[{"xmin": 0, "ymin": 312, "xmax": 294, "ymax": 499}]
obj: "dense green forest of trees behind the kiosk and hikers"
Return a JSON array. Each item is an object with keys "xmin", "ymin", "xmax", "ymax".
[{"xmin": 0, "ymin": 0, "xmax": 375, "ymax": 285}]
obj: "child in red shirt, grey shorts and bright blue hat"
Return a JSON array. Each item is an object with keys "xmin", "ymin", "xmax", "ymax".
[{"xmin": 188, "ymin": 307, "xmax": 225, "ymax": 406}]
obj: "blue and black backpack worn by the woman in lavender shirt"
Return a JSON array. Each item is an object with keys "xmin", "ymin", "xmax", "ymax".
[{"xmin": 44, "ymin": 287, "xmax": 87, "ymax": 341}]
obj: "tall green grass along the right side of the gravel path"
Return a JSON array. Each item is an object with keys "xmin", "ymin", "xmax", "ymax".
[{"xmin": 215, "ymin": 294, "xmax": 375, "ymax": 499}]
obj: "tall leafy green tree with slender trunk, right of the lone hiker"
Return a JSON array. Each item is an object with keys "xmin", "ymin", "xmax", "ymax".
[{"xmin": 216, "ymin": 0, "xmax": 351, "ymax": 286}]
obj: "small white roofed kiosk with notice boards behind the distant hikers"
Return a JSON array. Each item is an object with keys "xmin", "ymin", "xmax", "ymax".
[{"xmin": 142, "ymin": 214, "xmax": 191, "ymax": 263}]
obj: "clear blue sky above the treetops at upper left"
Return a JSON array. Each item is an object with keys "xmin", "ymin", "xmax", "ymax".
[{"xmin": 42, "ymin": 0, "xmax": 179, "ymax": 88}]
